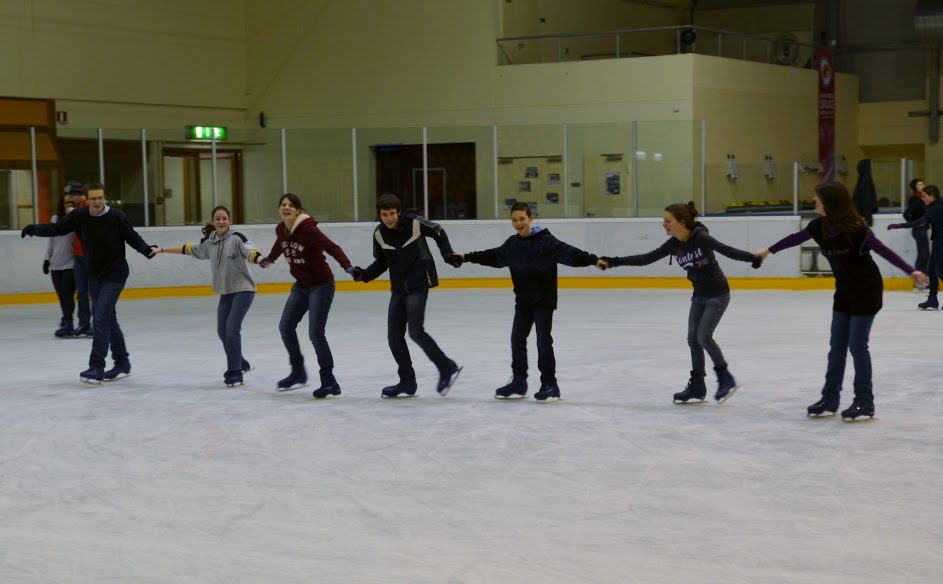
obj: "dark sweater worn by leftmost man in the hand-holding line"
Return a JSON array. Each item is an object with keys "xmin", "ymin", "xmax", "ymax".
[{"xmin": 33, "ymin": 207, "xmax": 151, "ymax": 282}]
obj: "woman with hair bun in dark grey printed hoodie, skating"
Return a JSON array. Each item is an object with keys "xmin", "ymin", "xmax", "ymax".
[{"xmin": 602, "ymin": 202, "xmax": 763, "ymax": 404}]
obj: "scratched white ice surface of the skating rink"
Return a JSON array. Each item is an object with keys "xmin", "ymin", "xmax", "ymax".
[{"xmin": 0, "ymin": 290, "xmax": 943, "ymax": 584}]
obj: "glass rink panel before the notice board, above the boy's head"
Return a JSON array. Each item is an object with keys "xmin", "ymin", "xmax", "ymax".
[{"xmin": 498, "ymin": 124, "xmax": 564, "ymax": 219}]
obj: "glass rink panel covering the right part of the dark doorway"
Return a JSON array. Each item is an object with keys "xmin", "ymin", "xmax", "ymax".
[{"xmin": 422, "ymin": 126, "xmax": 495, "ymax": 219}]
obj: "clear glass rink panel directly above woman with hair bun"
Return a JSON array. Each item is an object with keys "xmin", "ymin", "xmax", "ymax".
[{"xmin": 636, "ymin": 120, "xmax": 704, "ymax": 217}]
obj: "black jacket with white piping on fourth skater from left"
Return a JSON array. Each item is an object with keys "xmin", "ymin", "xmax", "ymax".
[{"xmin": 363, "ymin": 214, "xmax": 455, "ymax": 294}]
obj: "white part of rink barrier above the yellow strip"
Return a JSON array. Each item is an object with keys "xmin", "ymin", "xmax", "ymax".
[{"xmin": 0, "ymin": 215, "xmax": 916, "ymax": 294}]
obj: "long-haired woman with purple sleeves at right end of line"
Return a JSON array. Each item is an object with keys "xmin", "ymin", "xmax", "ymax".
[{"xmin": 757, "ymin": 183, "xmax": 929, "ymax": 420}]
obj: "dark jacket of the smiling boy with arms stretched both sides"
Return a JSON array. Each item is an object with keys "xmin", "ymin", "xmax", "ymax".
[{"xmin": 465, "ymin": 227, "xmax": 598, "ymax": 310}]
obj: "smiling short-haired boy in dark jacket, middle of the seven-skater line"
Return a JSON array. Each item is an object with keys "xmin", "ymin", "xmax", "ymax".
[{"xmin": 457, "ymin": 202, "xmax": 603, "ymax": 402}]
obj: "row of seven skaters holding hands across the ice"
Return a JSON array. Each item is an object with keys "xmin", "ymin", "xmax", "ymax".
[{"xmin": 23, "ymin": 183, "xmax": 920, "ymax": 420}]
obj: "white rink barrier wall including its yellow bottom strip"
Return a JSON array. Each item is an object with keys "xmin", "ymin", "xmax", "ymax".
[{"xmin": 0, "ymin": 213, "xmax": 916, "ymax": 304}]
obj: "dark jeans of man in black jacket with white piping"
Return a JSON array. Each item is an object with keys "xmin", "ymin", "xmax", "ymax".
[{"xmin": 386, "ymin": 290, "xmax": 452, "ymax": 381}]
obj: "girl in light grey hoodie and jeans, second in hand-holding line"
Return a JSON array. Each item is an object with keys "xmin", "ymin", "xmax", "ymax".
[{"xmin": 157, "ymin": 205, "xmax": 266, "ymax": 387}]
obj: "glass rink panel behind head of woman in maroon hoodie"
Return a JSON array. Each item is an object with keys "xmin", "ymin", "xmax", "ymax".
[{"xmin": 280, "ymin": 128, "xmax": 354, "ymax": 222}]
